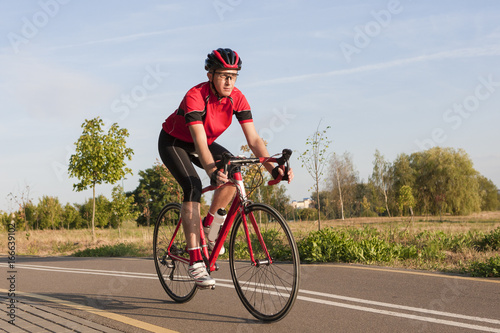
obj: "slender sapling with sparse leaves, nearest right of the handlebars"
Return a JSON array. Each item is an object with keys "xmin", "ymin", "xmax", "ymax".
[{"xmin": 299, "ymin": 121, "xmax": 331, "ymax": 230}]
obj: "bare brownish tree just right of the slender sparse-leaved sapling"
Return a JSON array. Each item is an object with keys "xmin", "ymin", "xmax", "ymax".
[{"xmin": 330, "ymin": 152, "xmax": 358, "ymax": 220}]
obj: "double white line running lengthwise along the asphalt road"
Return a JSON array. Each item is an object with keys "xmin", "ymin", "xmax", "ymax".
[{"xmin": 0, "ymin": 263, "xmax": 500, "ymax": 333}]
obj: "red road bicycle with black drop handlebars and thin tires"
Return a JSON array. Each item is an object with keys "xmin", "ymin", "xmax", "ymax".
[{"xmin": 153, "ymin": 149, "xmax": 300, "ymax": 322}]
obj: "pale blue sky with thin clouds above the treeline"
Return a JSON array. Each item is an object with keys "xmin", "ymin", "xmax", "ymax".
[{"xmin": 0, "ymin": 0, "xmax": 500, "ymax": 211}]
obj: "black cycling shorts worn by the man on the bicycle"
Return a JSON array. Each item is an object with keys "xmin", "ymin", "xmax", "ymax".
[{"xmin": 158, "ymin": 130, "xmax": 229, "ymax": 202}]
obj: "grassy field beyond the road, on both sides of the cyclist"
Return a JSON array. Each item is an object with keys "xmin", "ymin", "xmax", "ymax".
[{"xmin": 0, "ymin": 212, "xmax": 500, "ymax": 277}]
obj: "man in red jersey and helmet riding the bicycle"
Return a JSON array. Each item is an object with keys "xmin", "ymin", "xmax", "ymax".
[{"xmin": 158, "ymin": 48, "xmax": 293, "ymax": 288}]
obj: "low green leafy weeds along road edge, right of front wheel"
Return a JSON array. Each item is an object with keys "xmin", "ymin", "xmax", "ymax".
[{"xmin": 297, "ymin": 227, "xmax": 500, "ymax": 277}]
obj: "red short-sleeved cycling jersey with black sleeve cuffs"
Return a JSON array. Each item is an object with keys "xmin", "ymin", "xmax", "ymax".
[{"xmin": 162, "ymin": 82, "xmax": 253, "ymax": 145}]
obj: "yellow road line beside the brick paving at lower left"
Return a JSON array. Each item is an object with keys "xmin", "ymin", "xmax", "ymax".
[{"xmin": 0, "ymin": 289, "xmax": 177, "ymax": 333}]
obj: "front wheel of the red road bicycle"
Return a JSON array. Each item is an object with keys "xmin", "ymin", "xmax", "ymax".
[{"xmin": 229, "ymin": 203, "xmax": 300, "ymax": 322}]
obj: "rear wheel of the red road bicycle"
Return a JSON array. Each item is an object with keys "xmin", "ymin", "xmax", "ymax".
[{"xmin": 153, "ymin": 203, "xmax": 197, "ymax": 303}]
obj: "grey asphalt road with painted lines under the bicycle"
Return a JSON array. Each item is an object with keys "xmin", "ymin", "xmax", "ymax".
[{"xmin": 0, "ymin": 257, "xmax": 500, "ymax": 333}]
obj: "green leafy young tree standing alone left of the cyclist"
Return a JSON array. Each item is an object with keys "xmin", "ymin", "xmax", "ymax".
[{"xmin": 68, "ymin": 117, "xmax": 134, "ymax": 242}]
